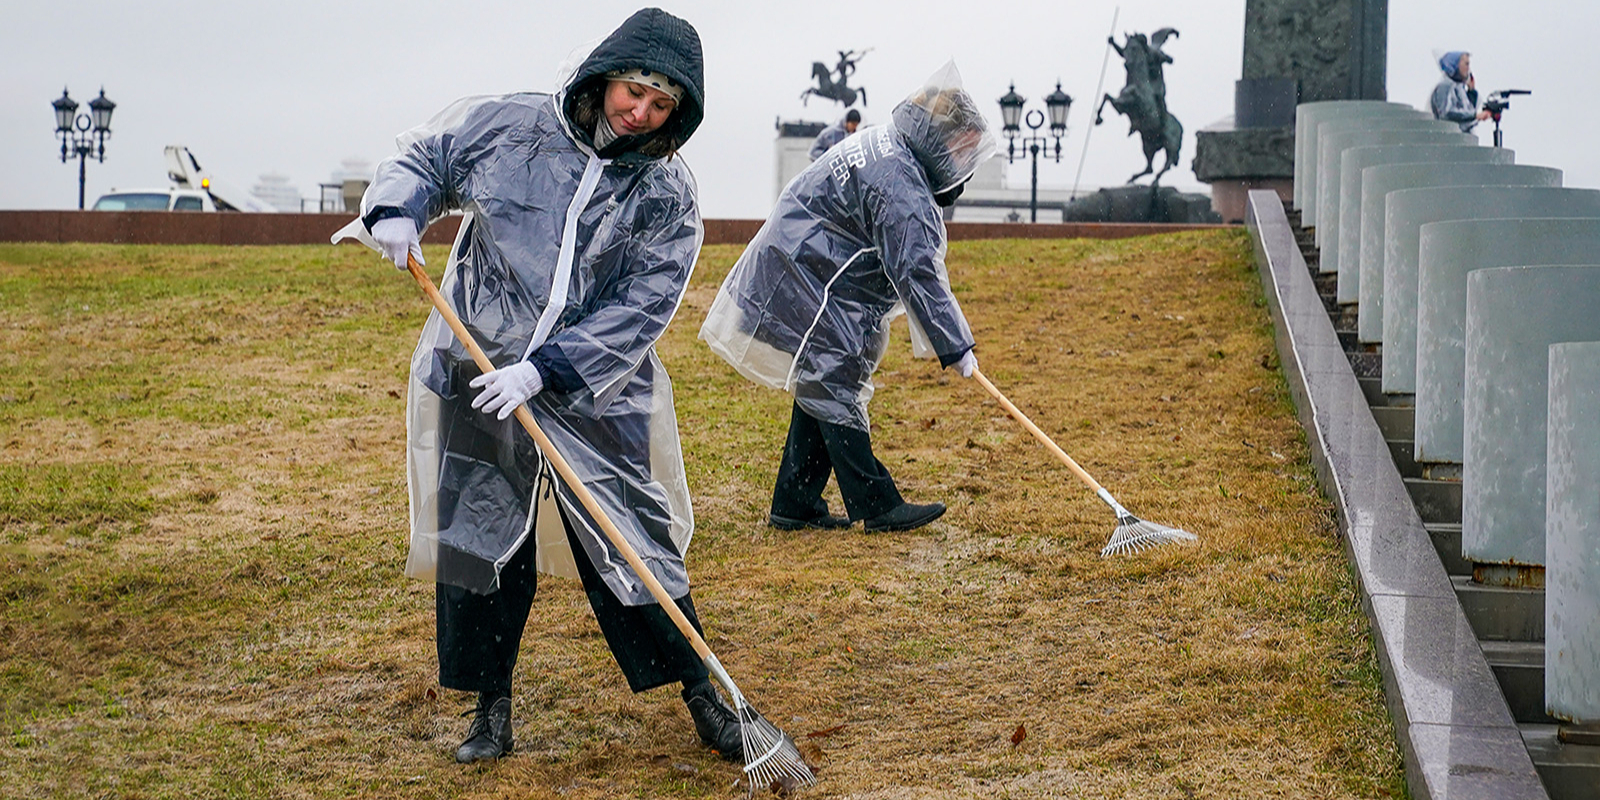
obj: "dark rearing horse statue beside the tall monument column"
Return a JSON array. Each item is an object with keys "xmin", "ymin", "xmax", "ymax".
[{"xmin": 1094, "ymin": 27, "xmax": 1184, "ymax": 186}]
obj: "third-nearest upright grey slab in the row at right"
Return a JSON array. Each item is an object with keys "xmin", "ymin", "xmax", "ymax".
[{"xmin": 1414, "ymin": 219, "xmax": 1600, "ymax": 464}]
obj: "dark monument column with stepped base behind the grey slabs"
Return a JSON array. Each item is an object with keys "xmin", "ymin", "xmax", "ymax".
[{"xmin": 1194, "ymin": 0, "xmax": 1389, "ymax": 222}]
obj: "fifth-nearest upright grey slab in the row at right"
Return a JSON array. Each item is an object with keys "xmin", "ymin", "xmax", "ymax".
[{"xmin": 1357, "ymin": 178, "xmax": 1562, "ymax": 347}]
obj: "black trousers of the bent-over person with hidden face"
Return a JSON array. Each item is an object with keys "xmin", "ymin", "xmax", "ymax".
[{"xmin": 773, "ymin": 403, "xmax": 904, "ymax": 520}]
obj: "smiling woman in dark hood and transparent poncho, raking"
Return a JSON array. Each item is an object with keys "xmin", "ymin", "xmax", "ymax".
[{"xmin": 344, "ymin": 8, "xmax": 741, "ymax": 763}]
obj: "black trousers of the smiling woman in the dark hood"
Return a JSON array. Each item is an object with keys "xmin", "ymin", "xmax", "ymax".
[{"xmin": 435, "ymin": 509, "xmax": 707, "ymax": 694}]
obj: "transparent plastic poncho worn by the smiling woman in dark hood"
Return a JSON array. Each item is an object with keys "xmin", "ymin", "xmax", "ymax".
[{"xmin": 336, "ymin": 82, "xmax": 702, "ymax": 605}]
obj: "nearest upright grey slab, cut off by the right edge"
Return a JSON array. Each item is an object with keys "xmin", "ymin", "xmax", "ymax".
[{"xmin": 1544, "ymin": 342, "xmax": 1600, "ymax": 725}]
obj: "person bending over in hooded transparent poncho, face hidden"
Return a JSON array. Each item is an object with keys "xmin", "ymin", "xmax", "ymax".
[{"xmin": 701, "ymin": 62, "xmax": 995, "ymax": 531}]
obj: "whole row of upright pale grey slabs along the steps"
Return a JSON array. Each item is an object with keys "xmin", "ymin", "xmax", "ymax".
[{"xmin": 1293, "ymin": 101, "xmax": 1600, "ymax": 728}]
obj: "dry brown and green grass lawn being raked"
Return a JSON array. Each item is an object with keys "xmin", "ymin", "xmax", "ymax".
[{"xmin": 0, "ymin": 232, "xmax": 1402, "ymax": 798}]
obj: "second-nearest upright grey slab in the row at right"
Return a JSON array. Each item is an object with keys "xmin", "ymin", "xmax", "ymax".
[{"xmin": 1461, "ymin": 264, "xmax": 1600, "ymax": 572}]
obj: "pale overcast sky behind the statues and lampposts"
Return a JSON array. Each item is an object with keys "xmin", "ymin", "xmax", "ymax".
[{"xmin": 0, "ymin": 0, "xmax": 1600, "ymax": 218}]
